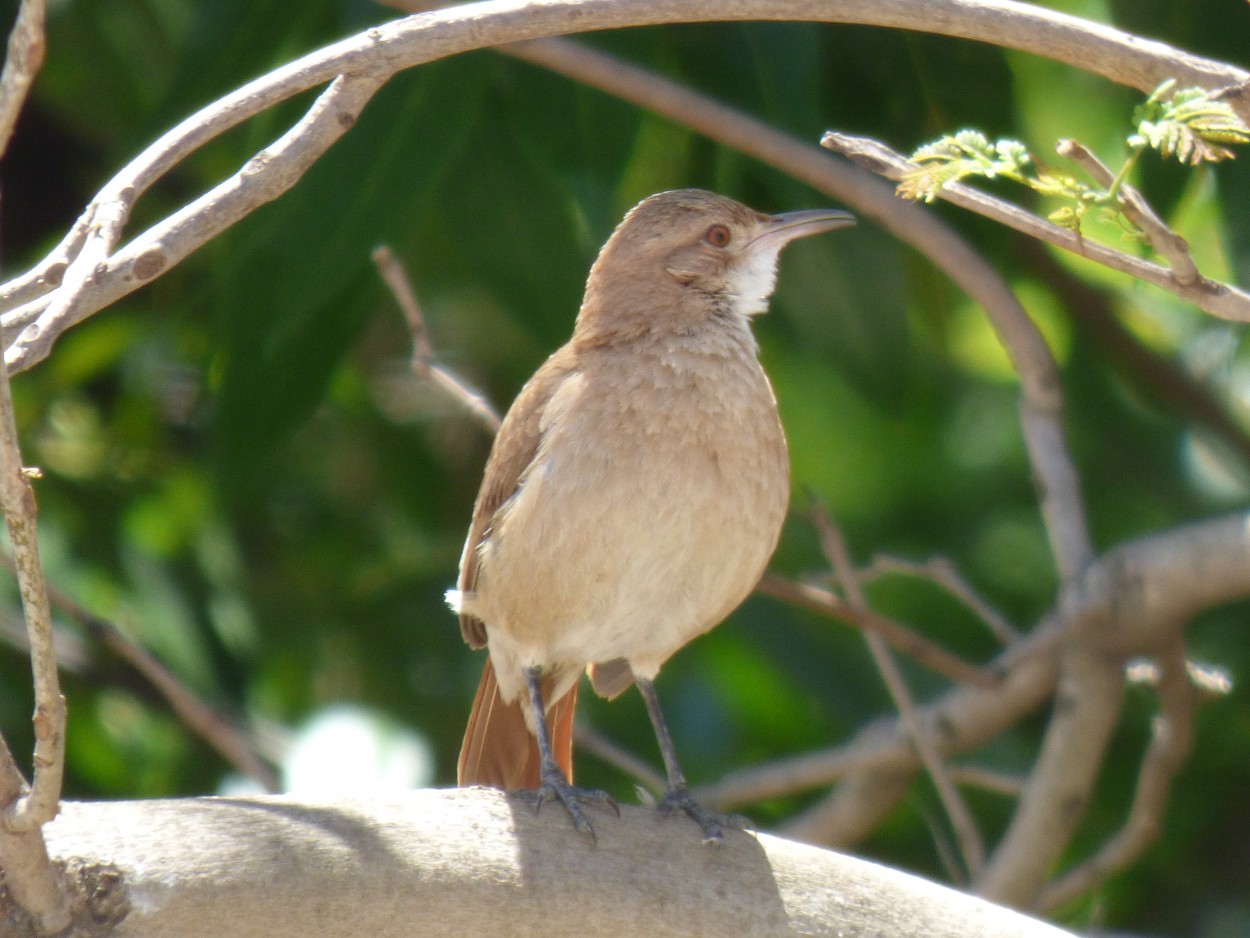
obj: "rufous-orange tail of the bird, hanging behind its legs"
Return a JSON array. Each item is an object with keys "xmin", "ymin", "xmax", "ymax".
[{"xmin": 456, "ymin": 658, "xmax": 578, "ymax": 789}]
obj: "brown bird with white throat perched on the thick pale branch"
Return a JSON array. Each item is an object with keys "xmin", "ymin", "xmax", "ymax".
[{"xmin": 448, "ymin": 189, "xmax": 854, "ymax": 842}]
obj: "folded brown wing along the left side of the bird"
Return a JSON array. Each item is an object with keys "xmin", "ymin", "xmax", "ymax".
[{"xmin": 456, "ymin": 345, "xmax": 576, "ymax": 648}]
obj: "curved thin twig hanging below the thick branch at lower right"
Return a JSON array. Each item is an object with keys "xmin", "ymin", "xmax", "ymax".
[{"xmin": 1038, "ymin": 642, "xmax": 1198, "ymax": 910}]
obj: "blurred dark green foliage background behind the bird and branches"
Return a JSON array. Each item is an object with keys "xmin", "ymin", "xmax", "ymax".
[{"xmin": 0, "ymin": 0, "xmax": 1250, "ymax": 938}]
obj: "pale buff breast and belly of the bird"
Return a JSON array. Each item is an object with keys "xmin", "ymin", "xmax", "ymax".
[{"xmin": 475, "ymin": 336, "xmax": 789, "ymax": 672}]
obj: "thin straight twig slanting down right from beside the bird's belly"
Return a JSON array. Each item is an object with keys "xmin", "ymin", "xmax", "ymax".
[{"xmin": 811, "ymin": 502, "xmax": 985, "ymax": 878}]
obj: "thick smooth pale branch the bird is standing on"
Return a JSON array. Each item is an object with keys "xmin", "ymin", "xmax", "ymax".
[{"xmin": 36, "ymin": 789, "xmax": 1068, "ymax": 938}]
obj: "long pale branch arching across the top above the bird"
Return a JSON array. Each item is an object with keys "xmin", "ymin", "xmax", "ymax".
[{"xmin": 0, "ymin": 0, "xmax": 1250, "ymax": 366}]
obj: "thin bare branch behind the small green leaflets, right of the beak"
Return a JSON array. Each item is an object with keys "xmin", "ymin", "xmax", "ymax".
[{"xmin": 821, "ymin": 131, "xmax": 1250, "ymax": 323}]
